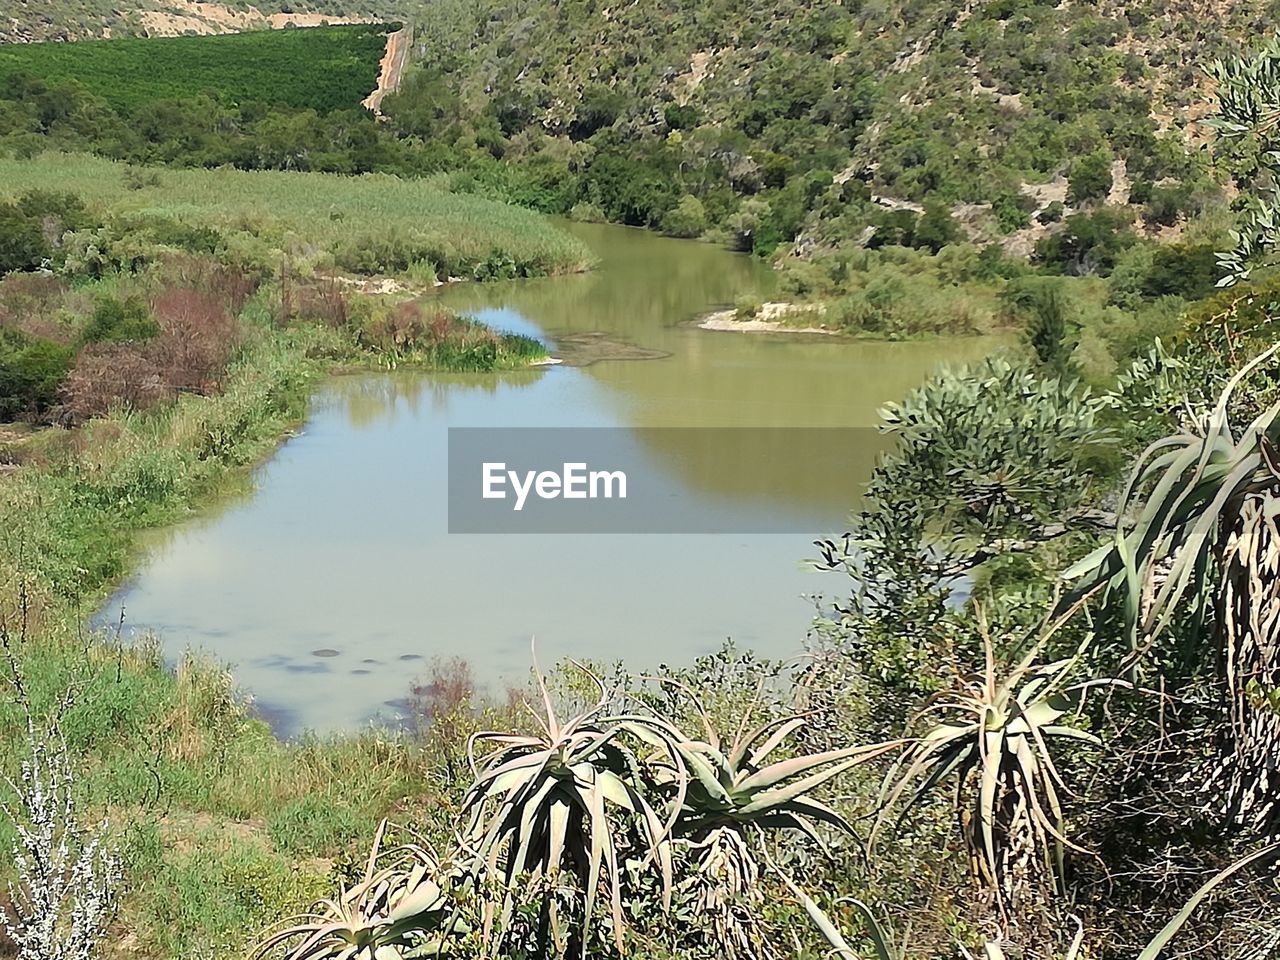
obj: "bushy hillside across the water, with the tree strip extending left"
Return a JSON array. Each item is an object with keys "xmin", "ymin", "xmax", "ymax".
[{"xmin": 0, "ymin": 0, "xmax": 1261, "ymax": 358}]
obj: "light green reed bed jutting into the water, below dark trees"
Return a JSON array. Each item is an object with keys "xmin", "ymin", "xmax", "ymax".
[{"xmin": 0, "ymin": 156, "xmax": 591, "ymax": 276}]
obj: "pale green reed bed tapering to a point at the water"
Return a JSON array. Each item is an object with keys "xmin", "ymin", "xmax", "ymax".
[{"xmin": 0, "ymin": 154, "xmax": 591, "ymax": 279}]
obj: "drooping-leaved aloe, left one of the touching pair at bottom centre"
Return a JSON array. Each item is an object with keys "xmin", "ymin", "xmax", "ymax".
[{"xmin": 463, "ymin": 657, "xmax": 684, "ymax": 952}]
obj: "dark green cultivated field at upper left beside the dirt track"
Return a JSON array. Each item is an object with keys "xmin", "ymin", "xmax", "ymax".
[{"xmin": 0, "ymin": 24, "xmax": 392, "ymax": 113}]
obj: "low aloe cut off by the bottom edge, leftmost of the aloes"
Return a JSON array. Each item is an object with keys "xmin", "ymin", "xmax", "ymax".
[{"xmin": 253, "ymin": 820, "xmax": 466, "ymax": 960}]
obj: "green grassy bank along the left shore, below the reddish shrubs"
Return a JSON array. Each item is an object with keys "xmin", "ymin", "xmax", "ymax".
[{"xmin": 0, "ymin": 267, "xmax": 540, "ymax": 959}]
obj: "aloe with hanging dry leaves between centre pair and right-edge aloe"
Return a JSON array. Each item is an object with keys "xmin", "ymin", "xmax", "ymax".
[{"xmin": 876, "ymin": 635, "xmax": 1098, "ymax": 909}]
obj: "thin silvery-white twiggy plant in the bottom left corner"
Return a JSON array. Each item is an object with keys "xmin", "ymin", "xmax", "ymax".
[{"xmin": 0, "ymin": 719, "xmax": 120, "ymax": 960}]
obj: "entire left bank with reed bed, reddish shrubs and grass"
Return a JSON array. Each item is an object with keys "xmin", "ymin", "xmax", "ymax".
[{"xmin": 0, "ymin": 156, "xmax": 565, "ymax": 960}]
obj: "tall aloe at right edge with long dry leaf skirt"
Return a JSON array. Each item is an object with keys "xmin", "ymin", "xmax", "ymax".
[{"xmin": 1064, "ymin": 346, "xmax": 1280, "ymax": 829}]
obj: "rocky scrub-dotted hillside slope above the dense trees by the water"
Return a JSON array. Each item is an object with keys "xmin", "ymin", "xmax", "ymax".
[{"xmin": 378, "ymin": 0, "xmax": 1274, "ymax": 252}]
